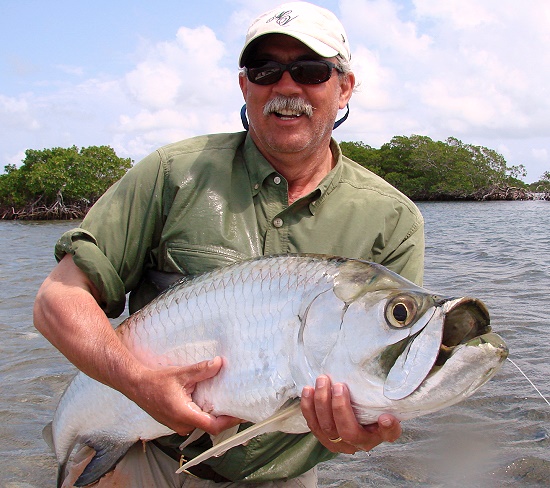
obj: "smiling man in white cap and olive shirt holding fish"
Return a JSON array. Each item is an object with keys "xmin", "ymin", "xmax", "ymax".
[{"xmin": 35, "ymin": 2, "xmax": 424, "ymax": 487}]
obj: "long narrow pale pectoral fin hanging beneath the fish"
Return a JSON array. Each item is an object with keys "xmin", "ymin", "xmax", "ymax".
[{"xmin": 176, "ymin": 398, "xmax": 301, "ymax": 473}]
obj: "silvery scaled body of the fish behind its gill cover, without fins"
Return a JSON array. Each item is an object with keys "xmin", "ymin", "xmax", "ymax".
[{"xmin": 53, "ymin": 257, "xmax": 336, "ymax": 460}]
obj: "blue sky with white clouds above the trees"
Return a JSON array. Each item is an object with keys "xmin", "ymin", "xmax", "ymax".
[{"xmin": 0, "ymin": 0, "xmax": 550, "ymax": 182}]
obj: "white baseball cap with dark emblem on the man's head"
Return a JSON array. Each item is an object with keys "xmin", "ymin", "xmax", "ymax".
[{"xmin": 239, "ymin": 2, "xmax": 351, "ymax": 68}]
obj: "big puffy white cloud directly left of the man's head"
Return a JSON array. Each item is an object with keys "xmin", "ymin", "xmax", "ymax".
[{"xmin": 114, "ymin": 26, "xmax": 242, "ymax": 157}]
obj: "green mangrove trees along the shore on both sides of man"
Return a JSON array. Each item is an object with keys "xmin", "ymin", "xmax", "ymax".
[{"xmin": 0, "ymin": 135, "xmax": 550, "ymax": 220}]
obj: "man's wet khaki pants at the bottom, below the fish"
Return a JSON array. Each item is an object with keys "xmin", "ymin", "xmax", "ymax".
[{"xmin": 63, "ymin": 443, "xmax": 317, "ymax": 488}]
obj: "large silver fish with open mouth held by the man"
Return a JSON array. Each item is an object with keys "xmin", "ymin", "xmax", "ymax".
[{"xmin": 52, "ymin": 255, "xmax": 507, "ymax": 486}]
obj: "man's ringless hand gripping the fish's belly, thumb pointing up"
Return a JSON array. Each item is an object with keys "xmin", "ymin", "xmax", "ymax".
[{"xmin": 131, "ymin": 357, "xmax": 242, "ymax": 435}]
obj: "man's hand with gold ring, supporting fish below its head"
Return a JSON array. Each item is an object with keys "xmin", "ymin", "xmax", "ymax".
[{"xmin": 301, "ymin": 375, "xmax": 401, "ymax": 454}]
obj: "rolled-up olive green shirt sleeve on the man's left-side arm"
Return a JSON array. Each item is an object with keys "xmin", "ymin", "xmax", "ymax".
[{"xmin": 55, "ymin": 152, "xmax": 164, "ymax": 317}]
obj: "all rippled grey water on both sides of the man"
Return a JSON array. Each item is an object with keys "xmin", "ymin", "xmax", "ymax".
[{"xmin": 0, "ymin": 201, "xmax": 550, "ymax": 488}]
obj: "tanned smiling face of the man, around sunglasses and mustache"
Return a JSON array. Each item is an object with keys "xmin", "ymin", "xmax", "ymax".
[{"xmin": 239, "ymin": 34, "xmax": 355, "ymax": 164}]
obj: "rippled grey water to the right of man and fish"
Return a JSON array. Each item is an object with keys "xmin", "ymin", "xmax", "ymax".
[{"xmin": 321, "ymin": 201, "xmax": 550, "ymax": 488}]
